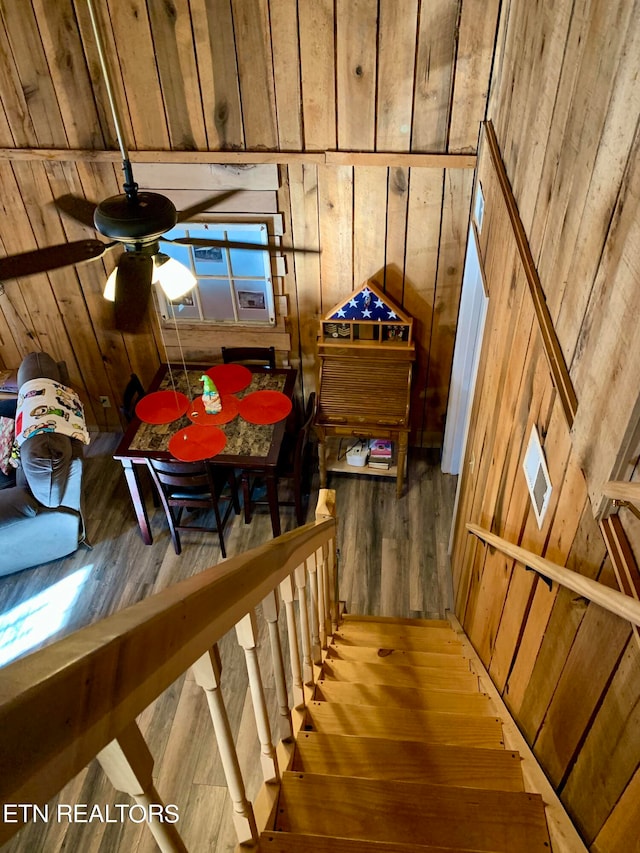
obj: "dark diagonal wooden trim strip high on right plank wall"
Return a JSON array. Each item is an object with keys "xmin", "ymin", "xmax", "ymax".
[{"xmin": 484, "ymin": 121, "xmax": 578, "ymax": 428}]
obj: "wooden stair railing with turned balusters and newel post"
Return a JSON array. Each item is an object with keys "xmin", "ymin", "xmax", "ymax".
[{"xmin": 0, "ymin": 489, "xmax": 337, "ymax": 853}]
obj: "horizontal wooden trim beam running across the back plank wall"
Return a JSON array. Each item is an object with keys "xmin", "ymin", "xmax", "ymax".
[{"xmin": 0, "ymin": 148, "xmax": 476, "ymax": 169}]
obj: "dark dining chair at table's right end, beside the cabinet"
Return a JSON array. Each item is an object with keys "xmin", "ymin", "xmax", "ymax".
[{"xmin": 241, "ymin": 391, "xmax": 316, "ymax": 525}]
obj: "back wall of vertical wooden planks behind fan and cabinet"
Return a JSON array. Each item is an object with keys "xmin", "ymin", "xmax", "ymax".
[{"xmin": 0, "ymin": 0, "xmax": 500, "ymax": 445}]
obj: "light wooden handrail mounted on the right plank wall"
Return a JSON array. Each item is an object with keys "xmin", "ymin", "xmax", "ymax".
[{"xmin": 467, "ymin": 523, "xmax": 640, "ymax": 625}]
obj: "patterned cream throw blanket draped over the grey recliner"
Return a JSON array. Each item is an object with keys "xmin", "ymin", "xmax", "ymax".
[{"xmin": 16, "ymin": 379, "xmax": 89, "ymax": 446}]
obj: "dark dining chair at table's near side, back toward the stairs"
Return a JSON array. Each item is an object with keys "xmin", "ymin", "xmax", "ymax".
[{"xmin": 147, "ymin": 459, "xmax": 240, "ymax": 557}]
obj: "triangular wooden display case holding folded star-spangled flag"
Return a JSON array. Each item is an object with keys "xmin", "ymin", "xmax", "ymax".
[{"xmin": 320, "ymin": 281, "xmax": 413, "ymax": 348}]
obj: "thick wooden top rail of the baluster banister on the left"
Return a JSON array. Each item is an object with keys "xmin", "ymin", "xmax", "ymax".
[{"xmin": 0, "ymin": 518, "xmax": 336, "ymax": 803}]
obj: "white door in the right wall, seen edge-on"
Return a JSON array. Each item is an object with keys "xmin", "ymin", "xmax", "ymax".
[{"xmin": 442, "ymin": 225, "xmax": 489, "ymax": 474}]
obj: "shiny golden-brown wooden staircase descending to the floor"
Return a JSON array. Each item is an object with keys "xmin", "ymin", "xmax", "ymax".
[{"xmin": 260, "ymin": 616, "xmax": 551, "ymax": 853}]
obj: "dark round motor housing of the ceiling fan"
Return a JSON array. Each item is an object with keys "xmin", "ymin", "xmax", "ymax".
[{"xmin": 93, "ymin": 192, "xmax": 178, "ymax": 243}]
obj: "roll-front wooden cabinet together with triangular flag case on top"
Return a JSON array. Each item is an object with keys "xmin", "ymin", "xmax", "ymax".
[{"xmin": 315, "ymin": 282, "xmax": 415, "ymax": 496}]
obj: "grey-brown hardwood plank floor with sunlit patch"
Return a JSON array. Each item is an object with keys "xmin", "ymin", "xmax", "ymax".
[{"xmin": 0, "ymin": 434, "xmax": 455, "ymax": 853}]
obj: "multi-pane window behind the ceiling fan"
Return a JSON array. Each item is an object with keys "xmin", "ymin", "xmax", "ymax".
[{"xmin": 158, "ymin": 222, "xmax": 275, "ymax": 326}]
